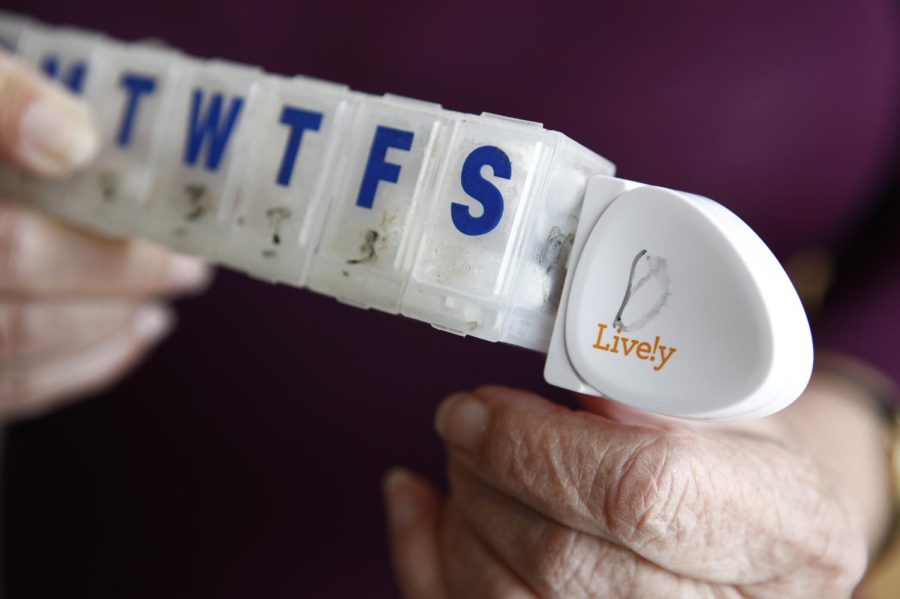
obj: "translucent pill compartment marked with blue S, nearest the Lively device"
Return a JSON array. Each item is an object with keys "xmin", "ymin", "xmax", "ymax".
[{"xmin": 403, "ymin": 117, "xmax": 553, "ymax": 341}]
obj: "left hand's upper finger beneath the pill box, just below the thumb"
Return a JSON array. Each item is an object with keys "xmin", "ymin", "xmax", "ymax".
[{"xmin": 0, "ymin": 204, "xmax": 210, "ymax": 299}]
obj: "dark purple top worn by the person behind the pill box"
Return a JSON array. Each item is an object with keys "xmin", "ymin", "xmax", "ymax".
[{"xmin": 4, "ymin": 0, "xmax": 900, "ymax": 598}]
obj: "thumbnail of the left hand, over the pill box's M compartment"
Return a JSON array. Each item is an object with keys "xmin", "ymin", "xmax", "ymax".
[{"xmin": 17, "ymin": 94, "xmax": 100, "ymax": 177}]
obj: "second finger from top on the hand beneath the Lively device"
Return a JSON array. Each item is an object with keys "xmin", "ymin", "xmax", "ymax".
[{"xmin": 449, "ymin": 460, "xmax": 712, "ymax": 599}]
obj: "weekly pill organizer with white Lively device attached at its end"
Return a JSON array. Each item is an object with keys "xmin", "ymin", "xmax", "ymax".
[{"xmin": 0, "ymin": 14, "xmax": 813, "ymax": 420}]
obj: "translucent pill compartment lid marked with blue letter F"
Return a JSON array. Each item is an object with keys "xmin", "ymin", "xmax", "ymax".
[{"xmin": 309, "ymin": 97, "xmax": 453, "ymax": 313}]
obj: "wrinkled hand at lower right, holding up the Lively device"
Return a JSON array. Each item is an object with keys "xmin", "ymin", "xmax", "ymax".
[{"xmin": 385, "ymin": 387, "xmax": 866, "ymax": 599}]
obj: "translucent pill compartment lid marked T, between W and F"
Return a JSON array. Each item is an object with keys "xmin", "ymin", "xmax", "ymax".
[{"xmin": 220, "ymin": 77, "xmax": 358, "ymax": 285}]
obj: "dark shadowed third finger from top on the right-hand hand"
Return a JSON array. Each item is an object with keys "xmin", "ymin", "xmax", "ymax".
[{"xmin": 441, "ymin": 500, "xmax": 538, "ymax": 599}]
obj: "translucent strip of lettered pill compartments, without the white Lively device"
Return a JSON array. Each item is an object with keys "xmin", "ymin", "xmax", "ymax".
[{"xmin": 0, "ymin": 16, "xmax": 613, "ymax": 350}]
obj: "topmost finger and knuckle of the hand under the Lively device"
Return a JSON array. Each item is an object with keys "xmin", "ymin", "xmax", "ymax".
[{"xmin": 436, "ymin": 387, "xmax": 856, "ymax": 583}]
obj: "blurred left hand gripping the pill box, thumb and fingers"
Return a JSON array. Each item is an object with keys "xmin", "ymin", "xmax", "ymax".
[{"xmin": 0, "ymin": 53, "xmax": 209, "ymax": 421}]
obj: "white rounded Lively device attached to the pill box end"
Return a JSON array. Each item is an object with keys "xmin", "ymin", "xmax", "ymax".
[{"xmin": 545, "ymin": 176, "xmax": 813, "ymax": 420}]
